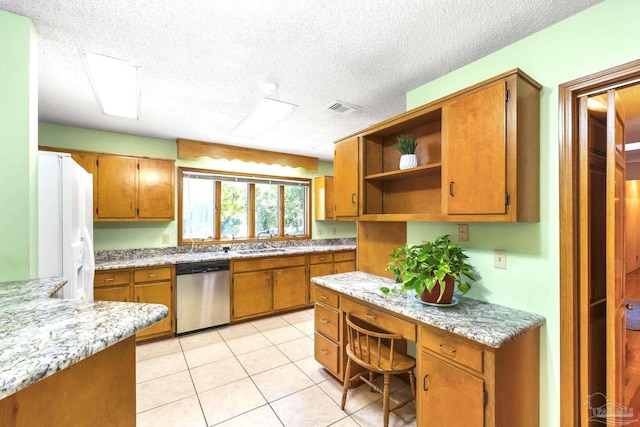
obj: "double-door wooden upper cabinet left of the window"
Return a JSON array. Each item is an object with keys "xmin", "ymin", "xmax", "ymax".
[{"xmin": 61, "ymin": 147, "xmax": 175, "ymax": 222}]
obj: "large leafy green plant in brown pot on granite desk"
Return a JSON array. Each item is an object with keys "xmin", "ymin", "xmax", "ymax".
[{"xmin": 380, "ymin": 235, "xmax": 476, "ymax": 304}]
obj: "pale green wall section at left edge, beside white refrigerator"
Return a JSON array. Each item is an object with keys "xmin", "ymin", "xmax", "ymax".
[{"xmin": 0, "ymin": 11, "xmax": 38, "ymax": 281}]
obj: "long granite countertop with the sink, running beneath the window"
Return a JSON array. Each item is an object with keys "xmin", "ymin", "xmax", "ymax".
[{"xmin": 96, "ymin": 239, "xmax": 356, "ymax": 271}]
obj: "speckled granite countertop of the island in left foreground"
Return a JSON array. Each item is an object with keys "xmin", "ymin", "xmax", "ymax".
[{"xmin": 0, "ymin": 278, "xmax": 169, "ymax": 399}]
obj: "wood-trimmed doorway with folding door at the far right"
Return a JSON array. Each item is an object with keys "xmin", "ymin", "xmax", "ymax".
[{"xmin": 560, "ymin": 61, "xmax": 640, "ymax": 426}]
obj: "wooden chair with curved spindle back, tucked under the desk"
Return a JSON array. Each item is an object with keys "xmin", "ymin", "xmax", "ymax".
[{"xmin": 342, "ymin": 313, "xmax": 416, "ymax": 427}]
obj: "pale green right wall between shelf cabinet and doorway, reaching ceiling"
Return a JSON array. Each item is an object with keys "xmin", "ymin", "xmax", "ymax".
[{"xmin": 407, "ymin": 0, "xmax": 640, "ymax": 426}]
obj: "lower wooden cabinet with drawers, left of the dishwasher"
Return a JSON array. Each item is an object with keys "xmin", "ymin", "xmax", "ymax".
[{"xmin": 93, "ymin": 265, "xmax": 175, "ymax": 341}]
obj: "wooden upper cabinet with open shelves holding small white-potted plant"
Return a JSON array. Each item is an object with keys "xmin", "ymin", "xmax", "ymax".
[{"xmin": 334, "ymin": 69, "xmax": 541, "ymax": 222}]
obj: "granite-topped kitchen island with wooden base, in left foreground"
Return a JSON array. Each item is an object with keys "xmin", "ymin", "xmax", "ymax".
[{"xmin": 0, "ymin": 278, "xmax": 168, "ymax": 426}]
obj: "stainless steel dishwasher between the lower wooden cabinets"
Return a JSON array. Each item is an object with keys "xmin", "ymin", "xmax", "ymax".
[{"xmin": 176, "ymin": 260, "xmax": 231, "ymax": 334}]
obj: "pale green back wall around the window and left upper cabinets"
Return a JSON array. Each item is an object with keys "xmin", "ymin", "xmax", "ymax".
[{"xmin": 39, "ymin": 123, "xmax": 356, "ymax": 250}]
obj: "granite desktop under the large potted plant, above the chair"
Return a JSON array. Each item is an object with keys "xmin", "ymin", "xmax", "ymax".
[{"xmin": 311, "ymin": 271, "xmax": 545, "ymax": 348}]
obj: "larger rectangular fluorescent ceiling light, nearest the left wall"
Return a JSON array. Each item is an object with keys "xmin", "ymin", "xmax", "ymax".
[{"xmin": 80, "ymin": 50, "xmax": 140, "ymax": 120}]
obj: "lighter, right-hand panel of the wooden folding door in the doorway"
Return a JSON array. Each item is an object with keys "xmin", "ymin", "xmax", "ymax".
[{"xmin": 606, "ymin": 89, "xmax": 626, "ymax": 405}]
